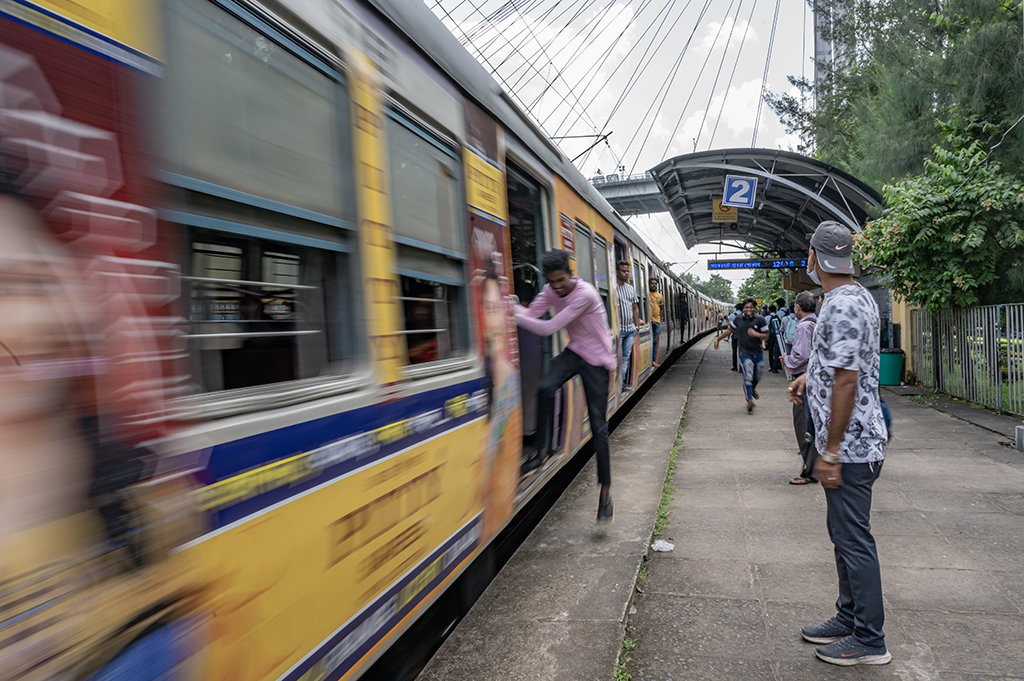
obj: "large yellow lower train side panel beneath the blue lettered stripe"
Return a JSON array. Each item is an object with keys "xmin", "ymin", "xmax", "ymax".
[{"xmin": 189, "ymin": 420, "xmax": 486, "ymax": 681}]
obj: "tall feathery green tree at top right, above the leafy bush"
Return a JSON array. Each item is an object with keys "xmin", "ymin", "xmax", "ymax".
[{"xmin": 766, "ymin": 0, "xmax": 1024, "ymax": 187}]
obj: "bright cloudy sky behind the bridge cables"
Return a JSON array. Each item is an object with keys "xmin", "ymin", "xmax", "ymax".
[{"xmin": 425, "ymin": 0, "xmax": 814, "ymax": 292}]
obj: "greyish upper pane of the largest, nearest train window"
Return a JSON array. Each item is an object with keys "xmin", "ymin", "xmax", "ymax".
[{"xmin": 164, "ymin": 0, "xmax": 354, "ymax": 218}]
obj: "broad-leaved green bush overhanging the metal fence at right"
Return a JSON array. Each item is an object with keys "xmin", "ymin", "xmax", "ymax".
[{"xmin": 856, "ymin": 119, "xmax": 1024, "ymax": 310}]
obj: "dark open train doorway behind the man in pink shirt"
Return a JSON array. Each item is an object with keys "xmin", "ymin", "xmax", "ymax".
[{"xmin": 506, "ymin": 162, "xmax": 559, "ymax": 468}]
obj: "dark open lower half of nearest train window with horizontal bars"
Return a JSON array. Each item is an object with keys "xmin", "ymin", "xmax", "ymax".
[{"xmin": 183, "ymin": 228, "xmax": 345, "ymax": 391}]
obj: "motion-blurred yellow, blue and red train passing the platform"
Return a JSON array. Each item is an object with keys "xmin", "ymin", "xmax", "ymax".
[{"xmin": 0, "ymin": 0, "xmax": 726, "ymax": 681}]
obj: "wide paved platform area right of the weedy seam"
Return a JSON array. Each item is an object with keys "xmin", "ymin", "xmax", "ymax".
[{"xmin": 622, "ymin": 337, "xmax": 1024, "ymax": 681}]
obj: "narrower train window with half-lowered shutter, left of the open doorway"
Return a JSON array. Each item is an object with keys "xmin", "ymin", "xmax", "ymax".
[{"xmin": 388, "ymin": 112, "xmax": 469, "ymax": 365}]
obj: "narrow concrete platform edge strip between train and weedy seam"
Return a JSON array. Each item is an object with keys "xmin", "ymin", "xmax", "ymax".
[{"xmin": 418, "ymin": 341, "xmax": 707, "ymax": 681}]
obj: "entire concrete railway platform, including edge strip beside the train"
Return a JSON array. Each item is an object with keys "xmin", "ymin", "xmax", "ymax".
[{"xmin": 420, "ymin": 341, "xmax": 1024, "ymax": 681}]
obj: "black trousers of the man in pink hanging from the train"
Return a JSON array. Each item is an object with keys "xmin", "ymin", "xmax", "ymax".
[{"xmin": 537, "ymin": 350, "xmax": 611, "ymax": 484}]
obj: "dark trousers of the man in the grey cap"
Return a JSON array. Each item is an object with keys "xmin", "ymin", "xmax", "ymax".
[{"xmin": 825, "ymin": 461, "xmax": 886, "ymax": 647}]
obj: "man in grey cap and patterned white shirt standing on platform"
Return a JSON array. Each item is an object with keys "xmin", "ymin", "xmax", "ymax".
[{"xmin": 790, "ymin": 221, "xmax": 892, "ymax": 667}]
